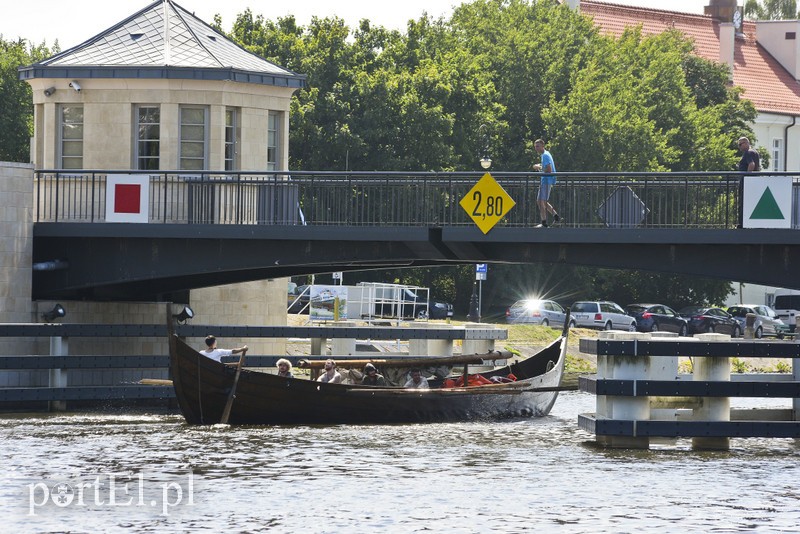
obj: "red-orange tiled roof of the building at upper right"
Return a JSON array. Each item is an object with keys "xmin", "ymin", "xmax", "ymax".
[{"xmin": 580, "ymin": 1, "xmax": 800, "ymax": 115}]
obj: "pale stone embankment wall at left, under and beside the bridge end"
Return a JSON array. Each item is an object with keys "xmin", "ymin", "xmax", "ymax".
[{"xmin": 0, "ymin": 162, "xmax": 286, "ymax": 387}]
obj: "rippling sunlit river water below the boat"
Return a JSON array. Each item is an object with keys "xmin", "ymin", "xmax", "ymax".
[{"xmin": 0, "ymin": 392, "xmax": 800, "ymax": 533}]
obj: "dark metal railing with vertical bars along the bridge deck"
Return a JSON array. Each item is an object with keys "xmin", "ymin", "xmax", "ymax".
[{"xmin": 34, "ymin": 170, "xmax": 800, "ymax": 228}]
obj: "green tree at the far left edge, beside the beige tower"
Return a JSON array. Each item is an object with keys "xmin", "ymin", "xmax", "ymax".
[{"xmin": 0, "ymin": 36, "xmax": 57, "ymax": 163}]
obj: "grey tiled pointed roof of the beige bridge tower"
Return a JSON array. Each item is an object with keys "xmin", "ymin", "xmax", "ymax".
[{"xmin": 20, "ymin": 0, "xmax": 305, "ymax": 87}]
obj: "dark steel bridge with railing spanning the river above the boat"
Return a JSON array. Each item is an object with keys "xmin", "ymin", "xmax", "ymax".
[{"xmin": 33, "ymin": 170, "xmax": 800, "ymax": 301}]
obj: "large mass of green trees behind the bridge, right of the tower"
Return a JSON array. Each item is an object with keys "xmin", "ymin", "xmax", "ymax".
[{"xmin": 216, "ymin": 0, "xmax": 757, "ymax": 312}]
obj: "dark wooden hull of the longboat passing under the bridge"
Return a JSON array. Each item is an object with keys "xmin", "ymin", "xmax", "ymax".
[{"xmin": 169, "ymin": 333, "xmax": 567, "ymax": 425}]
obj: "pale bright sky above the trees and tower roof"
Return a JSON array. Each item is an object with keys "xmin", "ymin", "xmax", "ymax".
[{"xmin": 0, "ymin": 0, "xmax": 710, "ymax": 50}]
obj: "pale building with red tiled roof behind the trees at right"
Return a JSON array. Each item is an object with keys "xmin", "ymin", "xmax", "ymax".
[{"xmin": 566, "ymin": 0, "xmax": 800, "ymax": 171}]
